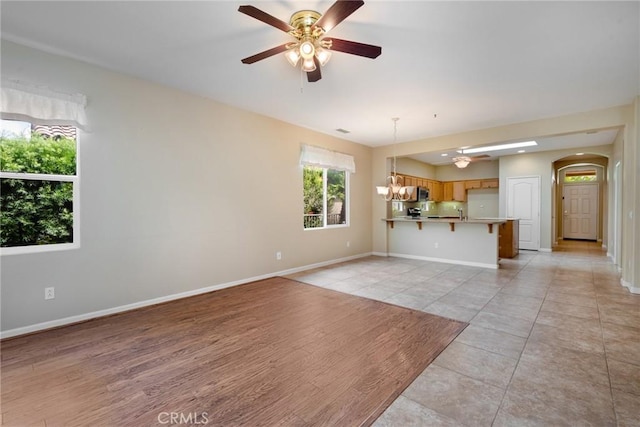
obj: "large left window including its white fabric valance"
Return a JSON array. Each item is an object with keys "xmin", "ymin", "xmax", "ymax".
[{"xmin": 0, "ymin": 81, "xmax": 87, "ymax": 255}]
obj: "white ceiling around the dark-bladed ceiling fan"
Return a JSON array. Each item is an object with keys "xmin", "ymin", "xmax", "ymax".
[{"xmin": 0, "ymin": 0, "xmax": 640, "ymax": 162}]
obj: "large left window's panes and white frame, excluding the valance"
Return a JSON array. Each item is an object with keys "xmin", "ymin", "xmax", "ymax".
[{"xmin": 0, "ymin": 120, "xmax": 79, "ymax": 254}]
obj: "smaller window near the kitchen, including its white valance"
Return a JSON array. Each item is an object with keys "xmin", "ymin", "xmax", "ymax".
[{"xmin": 300, "ymin": 145, "xmax": 356, "ymax": 230}]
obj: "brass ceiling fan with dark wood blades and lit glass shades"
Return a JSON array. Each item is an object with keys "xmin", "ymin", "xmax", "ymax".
[{"xmin": 238, "ymin": 0, "xmax": 382, "ymax": 82}]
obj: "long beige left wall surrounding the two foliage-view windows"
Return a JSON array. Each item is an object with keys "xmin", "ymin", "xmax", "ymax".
[{"xmin": 1, "ymin": 41, "xmax": 372, "ymax": 332}]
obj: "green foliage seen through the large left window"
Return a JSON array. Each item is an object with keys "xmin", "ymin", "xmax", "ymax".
[{"xmin": 0, "ymin": 133, "xmax": 76, "ymax": 247}]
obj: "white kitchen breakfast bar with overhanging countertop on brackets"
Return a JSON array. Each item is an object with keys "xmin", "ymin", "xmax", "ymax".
[{"xmin": 383, "ymin": 217, "xmax": 507, "ymax": 268}]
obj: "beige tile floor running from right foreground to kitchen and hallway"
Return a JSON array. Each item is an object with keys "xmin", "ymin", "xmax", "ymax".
[{"xmin": 290, "ymin": 242, "xmax": 640, "ymax": 427}]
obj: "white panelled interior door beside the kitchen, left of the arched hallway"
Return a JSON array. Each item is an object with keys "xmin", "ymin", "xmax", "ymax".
[{"xmin": 507, "ymin": 176, "xmax": 540, "ymax": 251}]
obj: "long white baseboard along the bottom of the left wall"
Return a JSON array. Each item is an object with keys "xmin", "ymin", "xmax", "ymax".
[{"xmin": 0, "ymin": 253, "xmax": 372, "ymax": 339}]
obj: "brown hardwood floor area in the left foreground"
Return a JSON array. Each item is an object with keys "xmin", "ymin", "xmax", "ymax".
[{"xmin": 1, "ymin": 278, "xmax": 466, "ymax": 427}]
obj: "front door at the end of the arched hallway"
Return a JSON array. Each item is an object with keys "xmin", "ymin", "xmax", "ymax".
[{"xmin": 562, "ymin": 183, "xmax": 598, "ymax": 240}]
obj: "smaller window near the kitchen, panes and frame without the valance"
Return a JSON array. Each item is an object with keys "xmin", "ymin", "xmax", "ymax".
[{"xmin": 303, "ymin": 166, "xmax": 349, "ymax": 229}]
